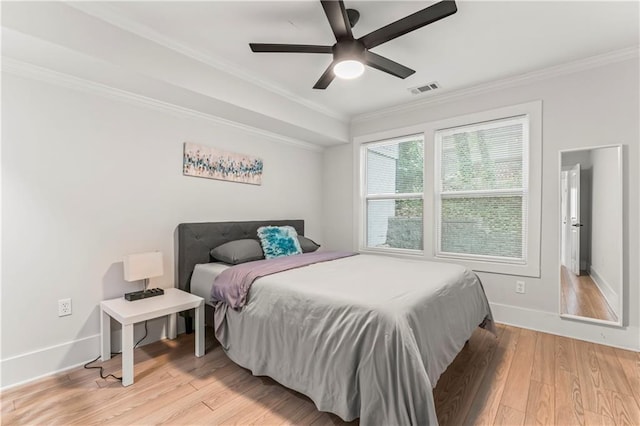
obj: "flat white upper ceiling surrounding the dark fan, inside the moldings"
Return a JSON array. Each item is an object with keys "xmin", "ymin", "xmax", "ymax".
[{"xmin": 72, "ymin": 0, "xmax": 640, "ymax": 118}]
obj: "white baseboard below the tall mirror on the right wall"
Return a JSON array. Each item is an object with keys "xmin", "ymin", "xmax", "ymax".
[{"xmin": 490, "ymin": 303, "xmax": 640, "ymax": 352}]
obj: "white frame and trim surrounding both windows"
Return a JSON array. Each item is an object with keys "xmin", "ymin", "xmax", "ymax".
[{"xmin": 353, "ymin": 101, "xmax": 542, "ymax": 278}]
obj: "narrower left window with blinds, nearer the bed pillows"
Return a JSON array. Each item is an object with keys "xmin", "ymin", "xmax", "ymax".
[{"xmin": 362, "ymin": 135, "xmax": 424, "ymax": 251}]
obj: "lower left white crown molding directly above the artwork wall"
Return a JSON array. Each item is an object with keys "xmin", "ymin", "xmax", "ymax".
[{"xmin": 2, "ymin": 56, "xmax": 324, "ymax": 152}]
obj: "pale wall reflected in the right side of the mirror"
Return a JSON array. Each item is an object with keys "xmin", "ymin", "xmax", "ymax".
[{"xmin": 591, "ymin": 148, "xmax": 622, "ymax": 308}]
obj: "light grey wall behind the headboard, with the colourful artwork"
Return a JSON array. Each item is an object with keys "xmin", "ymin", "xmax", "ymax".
[{"xmin": 1, "ymin": 73, "xmax": 323, "ymax": 387}]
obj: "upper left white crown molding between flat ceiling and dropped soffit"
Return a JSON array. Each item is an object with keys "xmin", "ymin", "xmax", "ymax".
[{"xmin": 65, "ymin": 1, "xmax": 349, "ymax": 123}]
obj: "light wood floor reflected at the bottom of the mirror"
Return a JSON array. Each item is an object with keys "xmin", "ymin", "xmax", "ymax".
[{"xmin": 560, "ymin": 266, "xmax": 618, "ymax": 321}]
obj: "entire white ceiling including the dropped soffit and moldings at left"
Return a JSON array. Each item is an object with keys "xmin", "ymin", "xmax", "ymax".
[{"xmin": 0, "ymin": 0, "xmax": 640, "ymax": 150}]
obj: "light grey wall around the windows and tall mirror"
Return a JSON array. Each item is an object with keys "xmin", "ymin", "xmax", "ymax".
[{"xmin": 325, "ymin": 57, "xmax": 640, "ymax": 350}]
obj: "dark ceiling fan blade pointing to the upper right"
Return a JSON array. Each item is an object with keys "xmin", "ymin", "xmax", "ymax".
[{"xmin": 359, "ymin": 0, "xmax": 458, "ymax": 49}]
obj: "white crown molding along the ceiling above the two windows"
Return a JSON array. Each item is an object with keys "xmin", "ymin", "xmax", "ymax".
[{"xmin": 351, "ymin": 46, "xmax": 640, "ymax": 124}]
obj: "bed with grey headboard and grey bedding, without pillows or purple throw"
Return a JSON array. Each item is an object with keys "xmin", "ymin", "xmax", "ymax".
[{"xmin": 178, "ymin": 220, "xmax": 493, "ymax": 425}]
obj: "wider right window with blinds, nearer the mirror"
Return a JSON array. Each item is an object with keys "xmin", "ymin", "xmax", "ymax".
[{"xmin": 435, "ymin": 116, "xmax": 529, "ymax": 264}]
